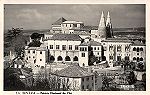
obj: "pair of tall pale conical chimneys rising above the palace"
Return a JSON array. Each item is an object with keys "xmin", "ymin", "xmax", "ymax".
[{"xmin": 98, "ymin": 11, "xmax": 112, "ymax": 39}]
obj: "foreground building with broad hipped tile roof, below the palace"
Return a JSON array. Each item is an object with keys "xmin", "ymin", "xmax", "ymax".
[{"xmin": 52, "ymin": 65, "xmax": 102, "ymax": 91}]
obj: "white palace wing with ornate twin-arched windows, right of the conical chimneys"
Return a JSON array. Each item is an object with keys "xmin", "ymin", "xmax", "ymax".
[{"xmin": 102, "ymin": 39, "xmax": 131, "ymax": 67}]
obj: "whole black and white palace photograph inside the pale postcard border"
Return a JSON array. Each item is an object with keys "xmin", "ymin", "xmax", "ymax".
[{"xmin": 3, "ymin": 4, "xmax": 147, "ymax": 94}]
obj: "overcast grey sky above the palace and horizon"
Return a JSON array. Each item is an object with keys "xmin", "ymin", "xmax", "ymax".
[{"xmin": 4, "ymin": 4, "xmax": 145, "ymax": 29}]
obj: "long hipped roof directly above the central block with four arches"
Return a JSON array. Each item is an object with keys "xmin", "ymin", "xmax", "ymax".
[{"xmin": 50, "ymin": 34, "xmax": 82, "ymax": 41}]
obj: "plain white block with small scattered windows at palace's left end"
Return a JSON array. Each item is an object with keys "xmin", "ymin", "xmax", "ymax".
[{"xmin": 25, "ymin": 42, "xmax": 48, "ymax": 68}]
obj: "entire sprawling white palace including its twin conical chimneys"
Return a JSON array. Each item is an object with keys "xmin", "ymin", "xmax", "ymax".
[{"xmin": 25, "ymin": 12, "xmax": 146, "ymax": 68}]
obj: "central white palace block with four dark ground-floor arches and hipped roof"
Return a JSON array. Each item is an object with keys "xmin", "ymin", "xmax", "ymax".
[{"xmin": 46, "ymin": 34, "xmax": 82, "ymax": 63}]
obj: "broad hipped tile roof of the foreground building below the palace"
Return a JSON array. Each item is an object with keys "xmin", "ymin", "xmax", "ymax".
[{"xmin": 51, "ymin": 65, "xmax": 93, "ymax": 78}]
